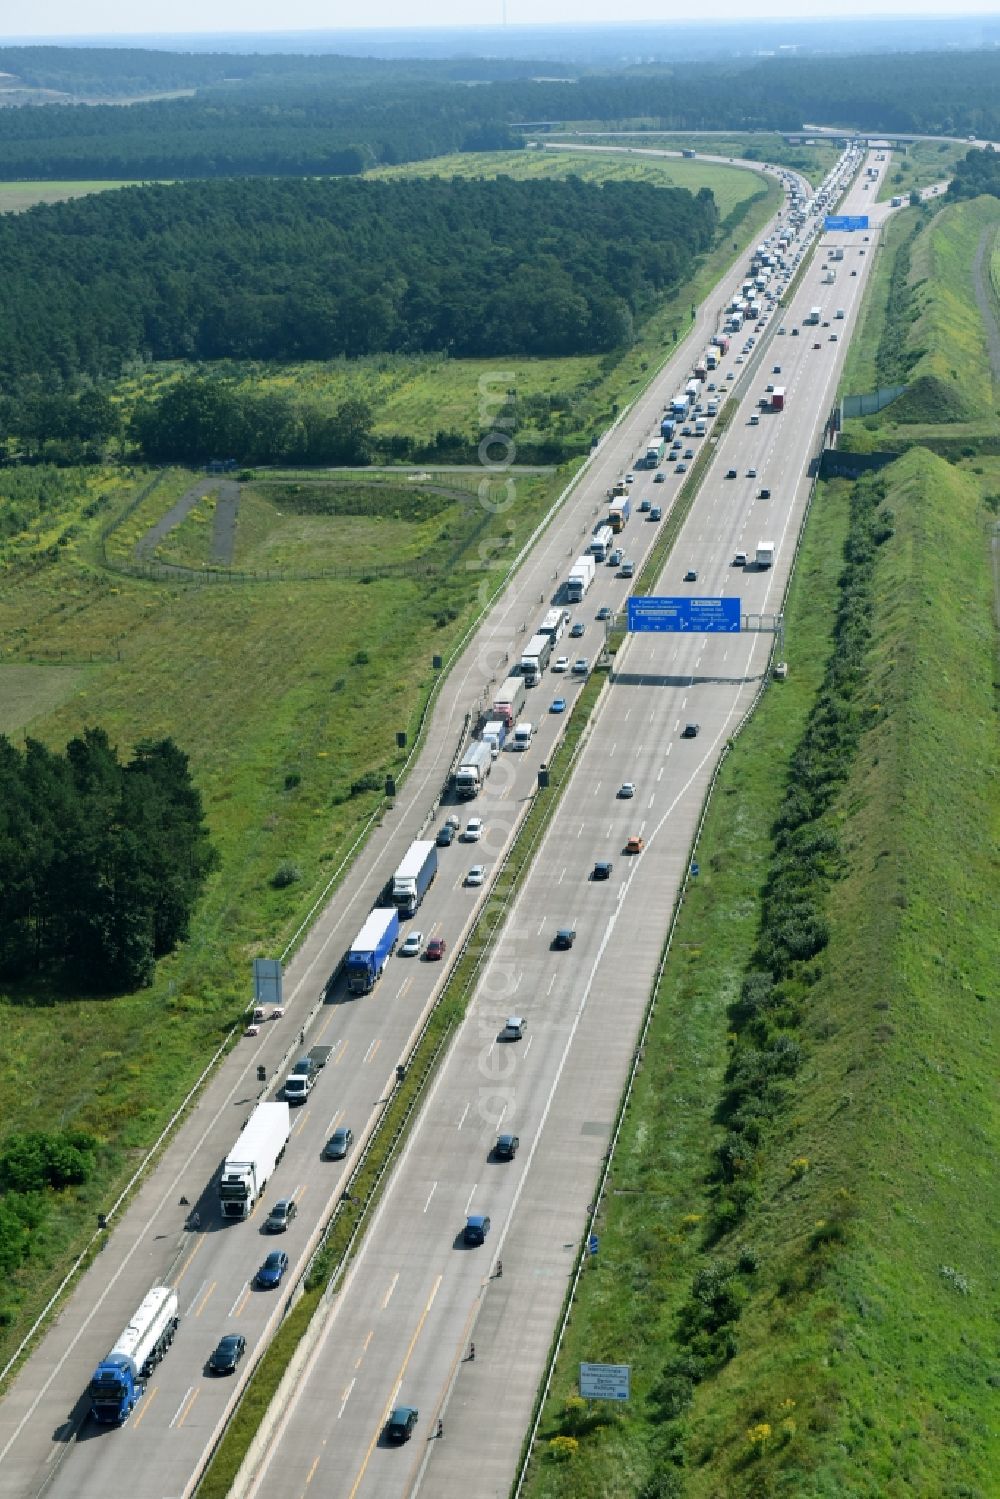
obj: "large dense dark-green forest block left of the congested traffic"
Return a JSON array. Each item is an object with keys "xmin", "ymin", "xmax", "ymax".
[{"xmin": 0, "ymin": 177, "xmax": 718, "ymax": 383}]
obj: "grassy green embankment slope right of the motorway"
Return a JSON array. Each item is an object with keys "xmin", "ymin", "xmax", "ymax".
[{"xmin": 531, "ymin": 451, "xmax": 1000, "ymax": 1499}]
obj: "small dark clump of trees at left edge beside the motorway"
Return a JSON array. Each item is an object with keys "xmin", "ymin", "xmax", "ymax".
[{"xmin": 0, "ymin": 729, "xmax": 217, "ymax": 994}]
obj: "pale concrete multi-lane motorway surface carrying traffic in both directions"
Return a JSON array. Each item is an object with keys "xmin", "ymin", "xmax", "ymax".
[{"xmin": 0, "ymin": 143, "xmax": 893, "ymax": 1499}]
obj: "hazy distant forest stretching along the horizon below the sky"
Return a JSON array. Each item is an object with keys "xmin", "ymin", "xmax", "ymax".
[{"xmin": 0, "ymin": 51, "xmax": 1000, "ymax": 180}]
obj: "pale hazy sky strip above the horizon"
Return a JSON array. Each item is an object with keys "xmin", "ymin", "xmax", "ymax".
[{"xmin": 0, "ymin": 0, "xmax": 1000, "ymax": 40}]
